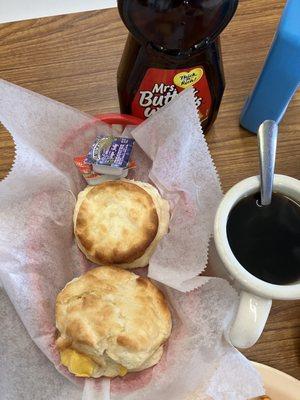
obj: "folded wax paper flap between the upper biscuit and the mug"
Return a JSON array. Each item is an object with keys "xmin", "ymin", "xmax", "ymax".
[{"xmin": 132, "ymin": 89, "xmax": 222, "ymax": 291}]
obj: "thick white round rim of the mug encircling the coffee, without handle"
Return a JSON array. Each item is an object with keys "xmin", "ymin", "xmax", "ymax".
[{"xmin": 214, "ymin": 174, "xmax": 300, "ymax": 300}]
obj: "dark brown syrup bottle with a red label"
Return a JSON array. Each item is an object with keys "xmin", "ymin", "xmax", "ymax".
[{"xmin": 118, "ymin": 0, "xmax": 238, "ymax": 133}]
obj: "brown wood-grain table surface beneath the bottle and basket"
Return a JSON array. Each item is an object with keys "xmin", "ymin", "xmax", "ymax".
[{"xmin": 0, "ymin": 0, "xmax": 300, "ymax": 379}]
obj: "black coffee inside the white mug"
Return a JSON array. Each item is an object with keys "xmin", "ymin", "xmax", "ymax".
[{"xmin": 227, "ymin": 193, "xmax": 300, "ymax": 285}]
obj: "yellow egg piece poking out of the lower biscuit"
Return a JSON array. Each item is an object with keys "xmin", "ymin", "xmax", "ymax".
[{"xmin": 60, "ymin": 348, "xmax": 97, "ymax": 378}]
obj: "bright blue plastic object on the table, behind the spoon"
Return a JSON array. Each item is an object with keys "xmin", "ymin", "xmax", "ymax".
[{"xmin": 240, "ymin": 0, "xmax": 300, "ymax": 133}]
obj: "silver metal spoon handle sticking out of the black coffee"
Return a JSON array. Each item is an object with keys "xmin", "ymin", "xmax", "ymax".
[{"xmin": 257, "ymin": 120, "xmax": 278, "ymax": 206}]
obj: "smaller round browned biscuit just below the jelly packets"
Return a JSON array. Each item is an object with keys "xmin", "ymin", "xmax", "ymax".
[{"xmin": 74, "ymin": 180, "xmax": 169, "ymax": 269}]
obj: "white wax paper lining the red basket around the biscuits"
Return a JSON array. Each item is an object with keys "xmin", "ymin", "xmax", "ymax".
[{"xmin": 0, "ymin": 80, "xmax": 263, "ymax": 400}]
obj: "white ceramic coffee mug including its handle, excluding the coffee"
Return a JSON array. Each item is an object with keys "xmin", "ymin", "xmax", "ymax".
[{"xmin": 214, "ymin": 175, "xmax": 300, "ymax": 348}]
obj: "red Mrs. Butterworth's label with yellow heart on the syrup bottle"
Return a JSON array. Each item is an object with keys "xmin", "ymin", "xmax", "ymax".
[{"xmin": 131, "ymin": 66, "xmax": 212, "ymax": 121}]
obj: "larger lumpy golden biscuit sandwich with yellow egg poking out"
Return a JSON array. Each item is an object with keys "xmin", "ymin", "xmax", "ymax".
[{"xmin": 56, "ymin": 267, "xmax": 172, "ymax": 377}]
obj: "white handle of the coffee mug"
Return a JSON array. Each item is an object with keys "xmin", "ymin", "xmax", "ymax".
[{"xmin": 229, "ymin": 291, "xmax": 272, "ymax": 349}]
